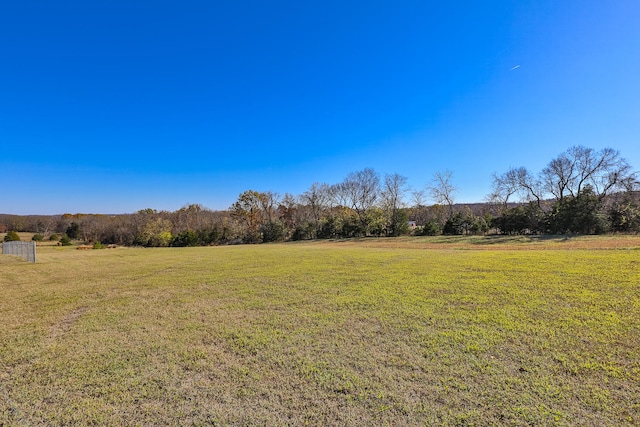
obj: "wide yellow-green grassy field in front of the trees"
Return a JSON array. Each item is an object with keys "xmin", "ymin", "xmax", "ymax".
[{"xmin": 0, "ymin": 237, "xmax": 640, "ymax": 426}]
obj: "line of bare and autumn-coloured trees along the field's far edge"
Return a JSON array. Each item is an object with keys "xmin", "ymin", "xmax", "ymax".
[{"xmin": 0, "ymin": 146, "xmax": 640, "ymax": 247}]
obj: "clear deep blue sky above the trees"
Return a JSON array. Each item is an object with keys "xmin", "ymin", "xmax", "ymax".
[{"xmin": 0, "ymin": 0, "xmax": 640, "ymax": 214}]
